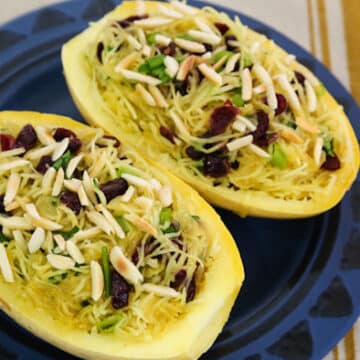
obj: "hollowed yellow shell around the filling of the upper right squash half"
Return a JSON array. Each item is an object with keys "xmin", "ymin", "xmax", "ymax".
[{"xmin": 62, "ymin": 2, "xmax": 359, "ymax": 218}]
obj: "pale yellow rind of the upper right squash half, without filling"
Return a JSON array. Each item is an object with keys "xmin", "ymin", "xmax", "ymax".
[{"xmin": 62, "ymin": 2, "xmax": 359, "ymax": 218}]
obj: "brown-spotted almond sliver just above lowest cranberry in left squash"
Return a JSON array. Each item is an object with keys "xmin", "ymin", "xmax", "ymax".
[{"xmin": 110, "ymin": 246, "xmax": 144, "ymax": 285}]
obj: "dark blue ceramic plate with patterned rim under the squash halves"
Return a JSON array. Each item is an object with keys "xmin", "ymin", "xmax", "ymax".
[{"xmin": 0, "ymin": 0, "xmax": 360, "ymax": 360}]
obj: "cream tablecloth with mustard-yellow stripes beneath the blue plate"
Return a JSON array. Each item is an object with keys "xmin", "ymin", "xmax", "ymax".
[{"xmin": 0, "ymin": 0, "xmax": 360, "ymax": 360}]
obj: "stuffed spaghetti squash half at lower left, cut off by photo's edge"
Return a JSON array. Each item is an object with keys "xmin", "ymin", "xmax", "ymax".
[{"xmin": 0, "ymin": 112, "xmax": 244, "ymax": 360}]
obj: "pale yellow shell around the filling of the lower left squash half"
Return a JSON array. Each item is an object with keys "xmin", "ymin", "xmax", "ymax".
[{"xmin": 0, "ymin": 112, "xmax": 244, "ymax": 360}]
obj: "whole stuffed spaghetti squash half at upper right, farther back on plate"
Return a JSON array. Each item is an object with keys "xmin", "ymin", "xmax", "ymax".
[{"xmin": 62, "ymin": 1, "xmax": 359, "ymax": 218}]
